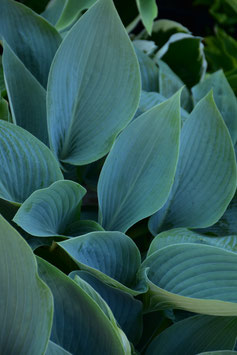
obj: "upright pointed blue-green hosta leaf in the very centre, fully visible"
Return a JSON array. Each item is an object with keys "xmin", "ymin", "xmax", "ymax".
[{"xmin": 98, "ymin": 92, "xmax": 180, "ymax": 232}]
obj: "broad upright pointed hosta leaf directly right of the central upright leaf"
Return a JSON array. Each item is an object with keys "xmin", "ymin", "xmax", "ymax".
[{"xmin": 149, "ymin": 92, "xmax": 236, "ymax": 235}]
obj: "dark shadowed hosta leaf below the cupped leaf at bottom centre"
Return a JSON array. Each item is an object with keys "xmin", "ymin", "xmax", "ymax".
[{"xmin": 70, "ymin": 271, "xmax": 142, "ymax": 344}]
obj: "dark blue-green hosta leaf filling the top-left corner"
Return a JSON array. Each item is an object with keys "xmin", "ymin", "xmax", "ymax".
[{"xmin": 0, "ymin": 0, "xmax": 61, "ymax": 87}]
